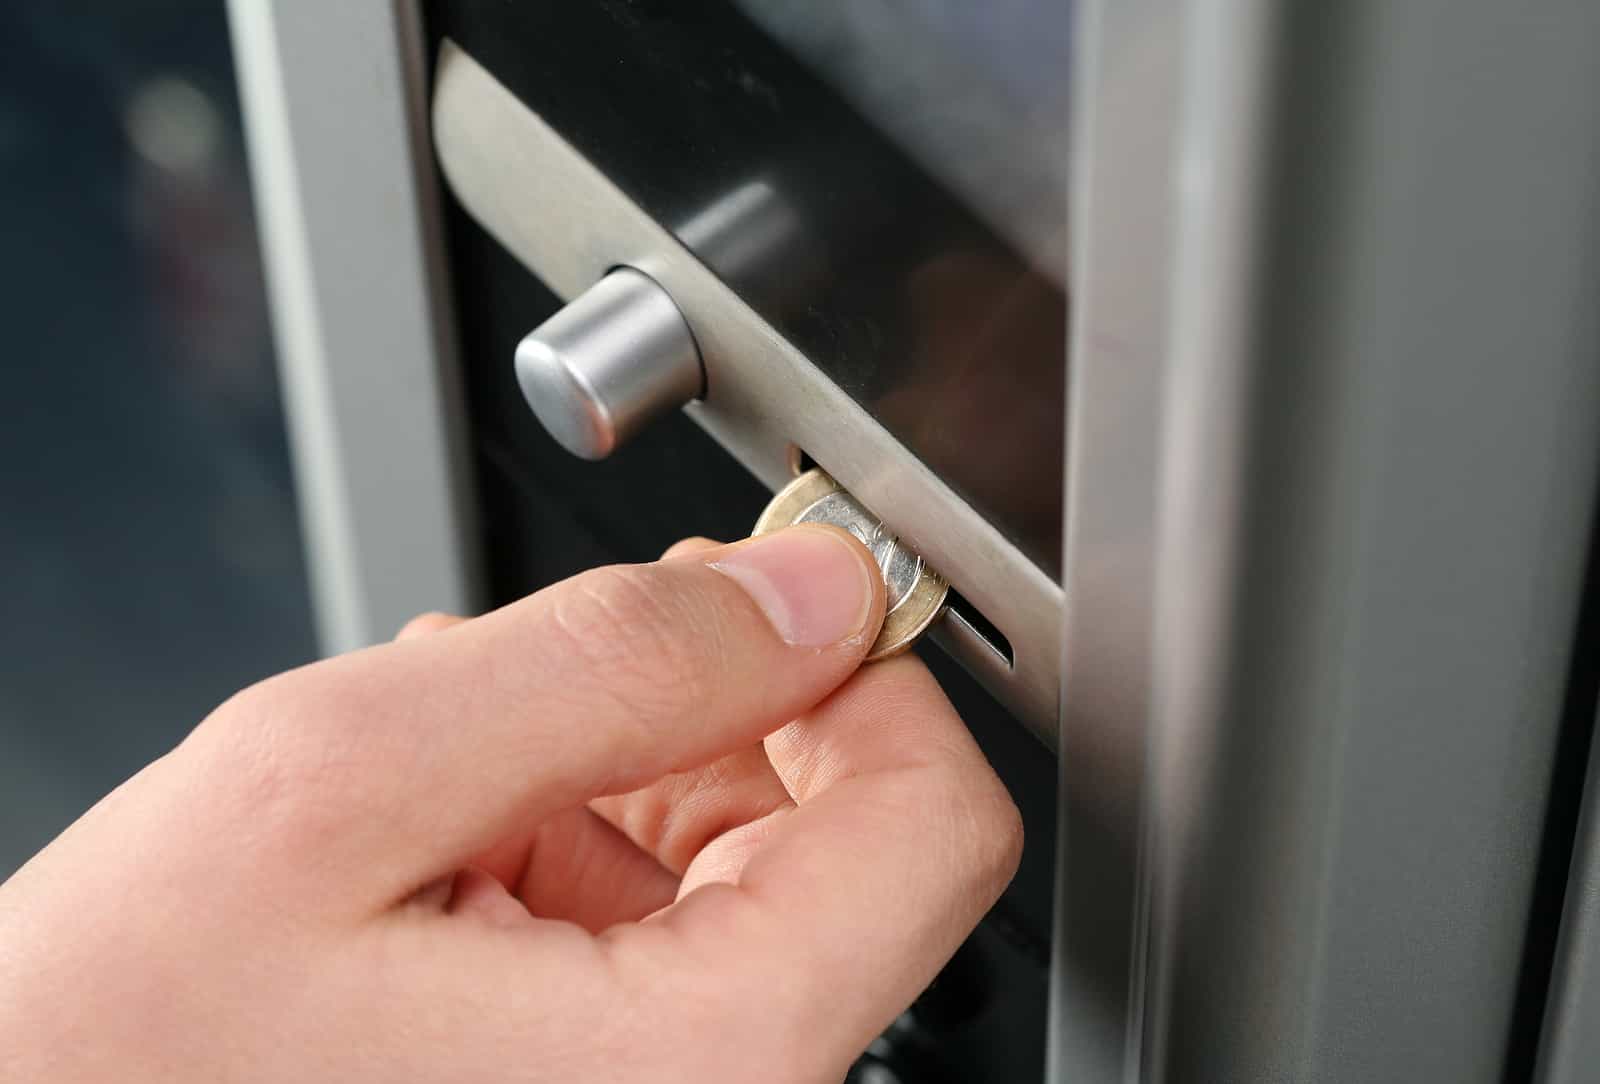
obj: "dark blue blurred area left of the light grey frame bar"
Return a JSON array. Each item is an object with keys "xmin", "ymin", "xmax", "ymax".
[{"xmin": 0, "ymin": 0, "xmax": 315, "ymax": 879}]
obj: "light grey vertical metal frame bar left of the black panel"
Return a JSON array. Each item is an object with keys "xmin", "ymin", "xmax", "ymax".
[{"xmin": 229, "ymin": 0, "xmax": 478, "ymax": 652}]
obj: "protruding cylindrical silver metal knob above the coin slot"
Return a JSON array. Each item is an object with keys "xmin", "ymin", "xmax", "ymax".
[{"xmin": 517, "ymin": 267, "xmax": 704, "ymax": 459}]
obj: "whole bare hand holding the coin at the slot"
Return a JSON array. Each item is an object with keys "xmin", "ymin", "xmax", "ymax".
[{"xmin": 0, "ymin": 526, "xmax": 1021, "ymax": 1082}]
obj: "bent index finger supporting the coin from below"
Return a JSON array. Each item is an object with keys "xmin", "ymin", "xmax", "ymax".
[{"xmin": 605, "ymin": 657, "xmax": 1022, "ymax": 1079}]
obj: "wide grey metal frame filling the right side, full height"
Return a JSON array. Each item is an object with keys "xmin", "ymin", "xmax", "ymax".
[{"xmin": 1053, "ymin": 0, "xmax": 1600, "ymax": 1082}]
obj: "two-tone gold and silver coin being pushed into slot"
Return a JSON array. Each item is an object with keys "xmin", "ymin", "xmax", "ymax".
[{"xmin": 750, "ymin": 468, "xmax": 950, "ymax": 662}]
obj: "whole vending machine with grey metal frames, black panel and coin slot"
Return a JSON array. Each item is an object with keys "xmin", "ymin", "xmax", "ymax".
[{"xmin": 230, "ymin": 0, "xmax": 1600, "ymax": 1084}]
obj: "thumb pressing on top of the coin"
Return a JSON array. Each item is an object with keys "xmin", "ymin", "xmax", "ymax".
[{"xmin": 179, "ymin": 526, "xmax": 885, "ymax": 908}]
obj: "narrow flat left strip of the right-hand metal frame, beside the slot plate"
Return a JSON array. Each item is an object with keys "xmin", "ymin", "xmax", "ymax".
[{"xmin": 1050, "ymin": 0, "xmax": 1182, "ymax": 1082}]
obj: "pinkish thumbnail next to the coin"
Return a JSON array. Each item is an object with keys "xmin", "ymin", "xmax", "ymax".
[{"xmin": 710, "ymin": 528, "xmax": 878, "ymax": 648}]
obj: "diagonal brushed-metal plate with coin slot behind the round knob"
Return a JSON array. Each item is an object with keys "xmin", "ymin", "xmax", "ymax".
[{"xmin": 434, "ymin": 42, "xmax": 1062, "ymax": 742}]
